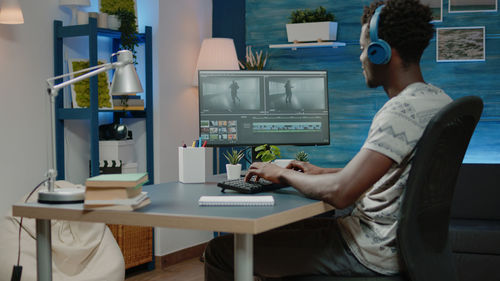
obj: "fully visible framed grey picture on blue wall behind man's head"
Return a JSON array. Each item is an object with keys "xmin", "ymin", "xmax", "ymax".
[{"xmin": 436, "ymin": 26, "xmax": 486, "ymax": 62}]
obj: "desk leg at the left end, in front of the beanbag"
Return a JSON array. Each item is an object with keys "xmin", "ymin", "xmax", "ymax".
[{"xmin": 36, "ymin": 219, "xmax": 52, "ymax": 281}]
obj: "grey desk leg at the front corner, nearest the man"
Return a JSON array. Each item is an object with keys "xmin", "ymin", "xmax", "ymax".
[{"xmin": 234, "ymin": 234, "xmax": 253, "ymax": 281}]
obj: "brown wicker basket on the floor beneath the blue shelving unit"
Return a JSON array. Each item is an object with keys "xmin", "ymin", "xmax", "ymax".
[{"xmin": 108, "ymin": 224, "xmax": 153, "ymax": 269}]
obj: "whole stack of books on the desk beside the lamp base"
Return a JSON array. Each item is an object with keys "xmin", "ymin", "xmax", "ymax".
[{"xmin": 83, "ymin": 173, "xmax": 151, "ymax": 211}]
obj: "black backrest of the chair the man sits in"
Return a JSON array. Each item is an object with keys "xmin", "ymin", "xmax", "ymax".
[{"xmin": 397, "ymin": 96, "xmax": 483, "ymax": 281}]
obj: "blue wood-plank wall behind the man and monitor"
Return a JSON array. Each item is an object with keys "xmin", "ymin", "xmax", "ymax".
[{"xmin": 245, "ymin": 0, "xmax": 500, "ymax": 167}]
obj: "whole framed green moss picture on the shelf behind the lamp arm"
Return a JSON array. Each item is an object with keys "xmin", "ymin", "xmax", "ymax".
[{"xmin": 68, "ymin": 59, "xmax": 113, "ymax": 109}]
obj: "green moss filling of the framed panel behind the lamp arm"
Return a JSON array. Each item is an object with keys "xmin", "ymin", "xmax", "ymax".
[{"xmin": 72, "ymin": 61, "xmax": 111, "ymax": 108}]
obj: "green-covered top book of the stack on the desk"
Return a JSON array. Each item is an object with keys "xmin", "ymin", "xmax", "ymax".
[{"xmin": 85, "ymin": 173, "xmax": 148, "ymax": 188}]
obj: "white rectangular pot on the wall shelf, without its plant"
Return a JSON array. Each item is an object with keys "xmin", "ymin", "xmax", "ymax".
[{"xmin": 286, "ymin": 21, "xmax": 338, "ymax": 42}]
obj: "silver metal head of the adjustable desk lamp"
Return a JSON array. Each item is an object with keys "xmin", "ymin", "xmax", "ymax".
[{"xmin": 111, "ymin": 50, "xmax": 144, "ymax": 95}]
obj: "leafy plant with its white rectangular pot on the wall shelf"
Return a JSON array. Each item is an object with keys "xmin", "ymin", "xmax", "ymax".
[{"xmin": 286, "ymin": 6, "xmax": 338, "ymax": 43}]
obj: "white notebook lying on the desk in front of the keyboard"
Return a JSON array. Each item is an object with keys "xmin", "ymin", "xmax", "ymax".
[{"xmin": 198, "ymin": 195, "xmax": 274, "ymax": 206}]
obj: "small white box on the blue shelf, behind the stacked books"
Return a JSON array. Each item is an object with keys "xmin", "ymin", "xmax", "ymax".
[{"xmin": 99, "ymin": 140, "xmax": 137, "ymax": 164}]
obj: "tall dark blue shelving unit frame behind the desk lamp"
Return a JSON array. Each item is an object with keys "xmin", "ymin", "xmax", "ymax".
[{"xmin": 54, "ymin": 18, "xmax": 154, "ymax": 183}]
